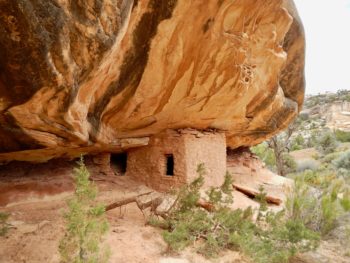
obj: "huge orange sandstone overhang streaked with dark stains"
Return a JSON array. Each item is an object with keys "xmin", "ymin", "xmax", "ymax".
[{"xmin": 0, "ymin": 0, "xmax": 304, "ymax": 161}]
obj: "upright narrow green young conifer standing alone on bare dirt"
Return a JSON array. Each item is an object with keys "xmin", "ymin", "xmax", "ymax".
[{"xmin": 59, "ymin": 158, "xmax": 109, "ymax": 263}]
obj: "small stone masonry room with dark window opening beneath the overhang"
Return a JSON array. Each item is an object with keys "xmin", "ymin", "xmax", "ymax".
[{"xmin": 126, "ymin": 129, "xmax": 226, "ymax": 191}]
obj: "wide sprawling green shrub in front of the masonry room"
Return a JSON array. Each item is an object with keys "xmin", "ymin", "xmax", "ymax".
[{"xmin": 149, "ymin": 166, "xmax": 319, "ymax": 263}]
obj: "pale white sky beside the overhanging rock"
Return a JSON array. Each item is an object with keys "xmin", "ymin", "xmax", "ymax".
[{"xmin": 294, "ymin": 0, "xmax": 350, "ymax": 94}]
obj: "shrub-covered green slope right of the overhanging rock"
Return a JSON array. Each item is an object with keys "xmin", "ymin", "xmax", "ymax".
[{"xmin": 251, "ymin": 91, "xmax": 350, "ymax": 256}]
